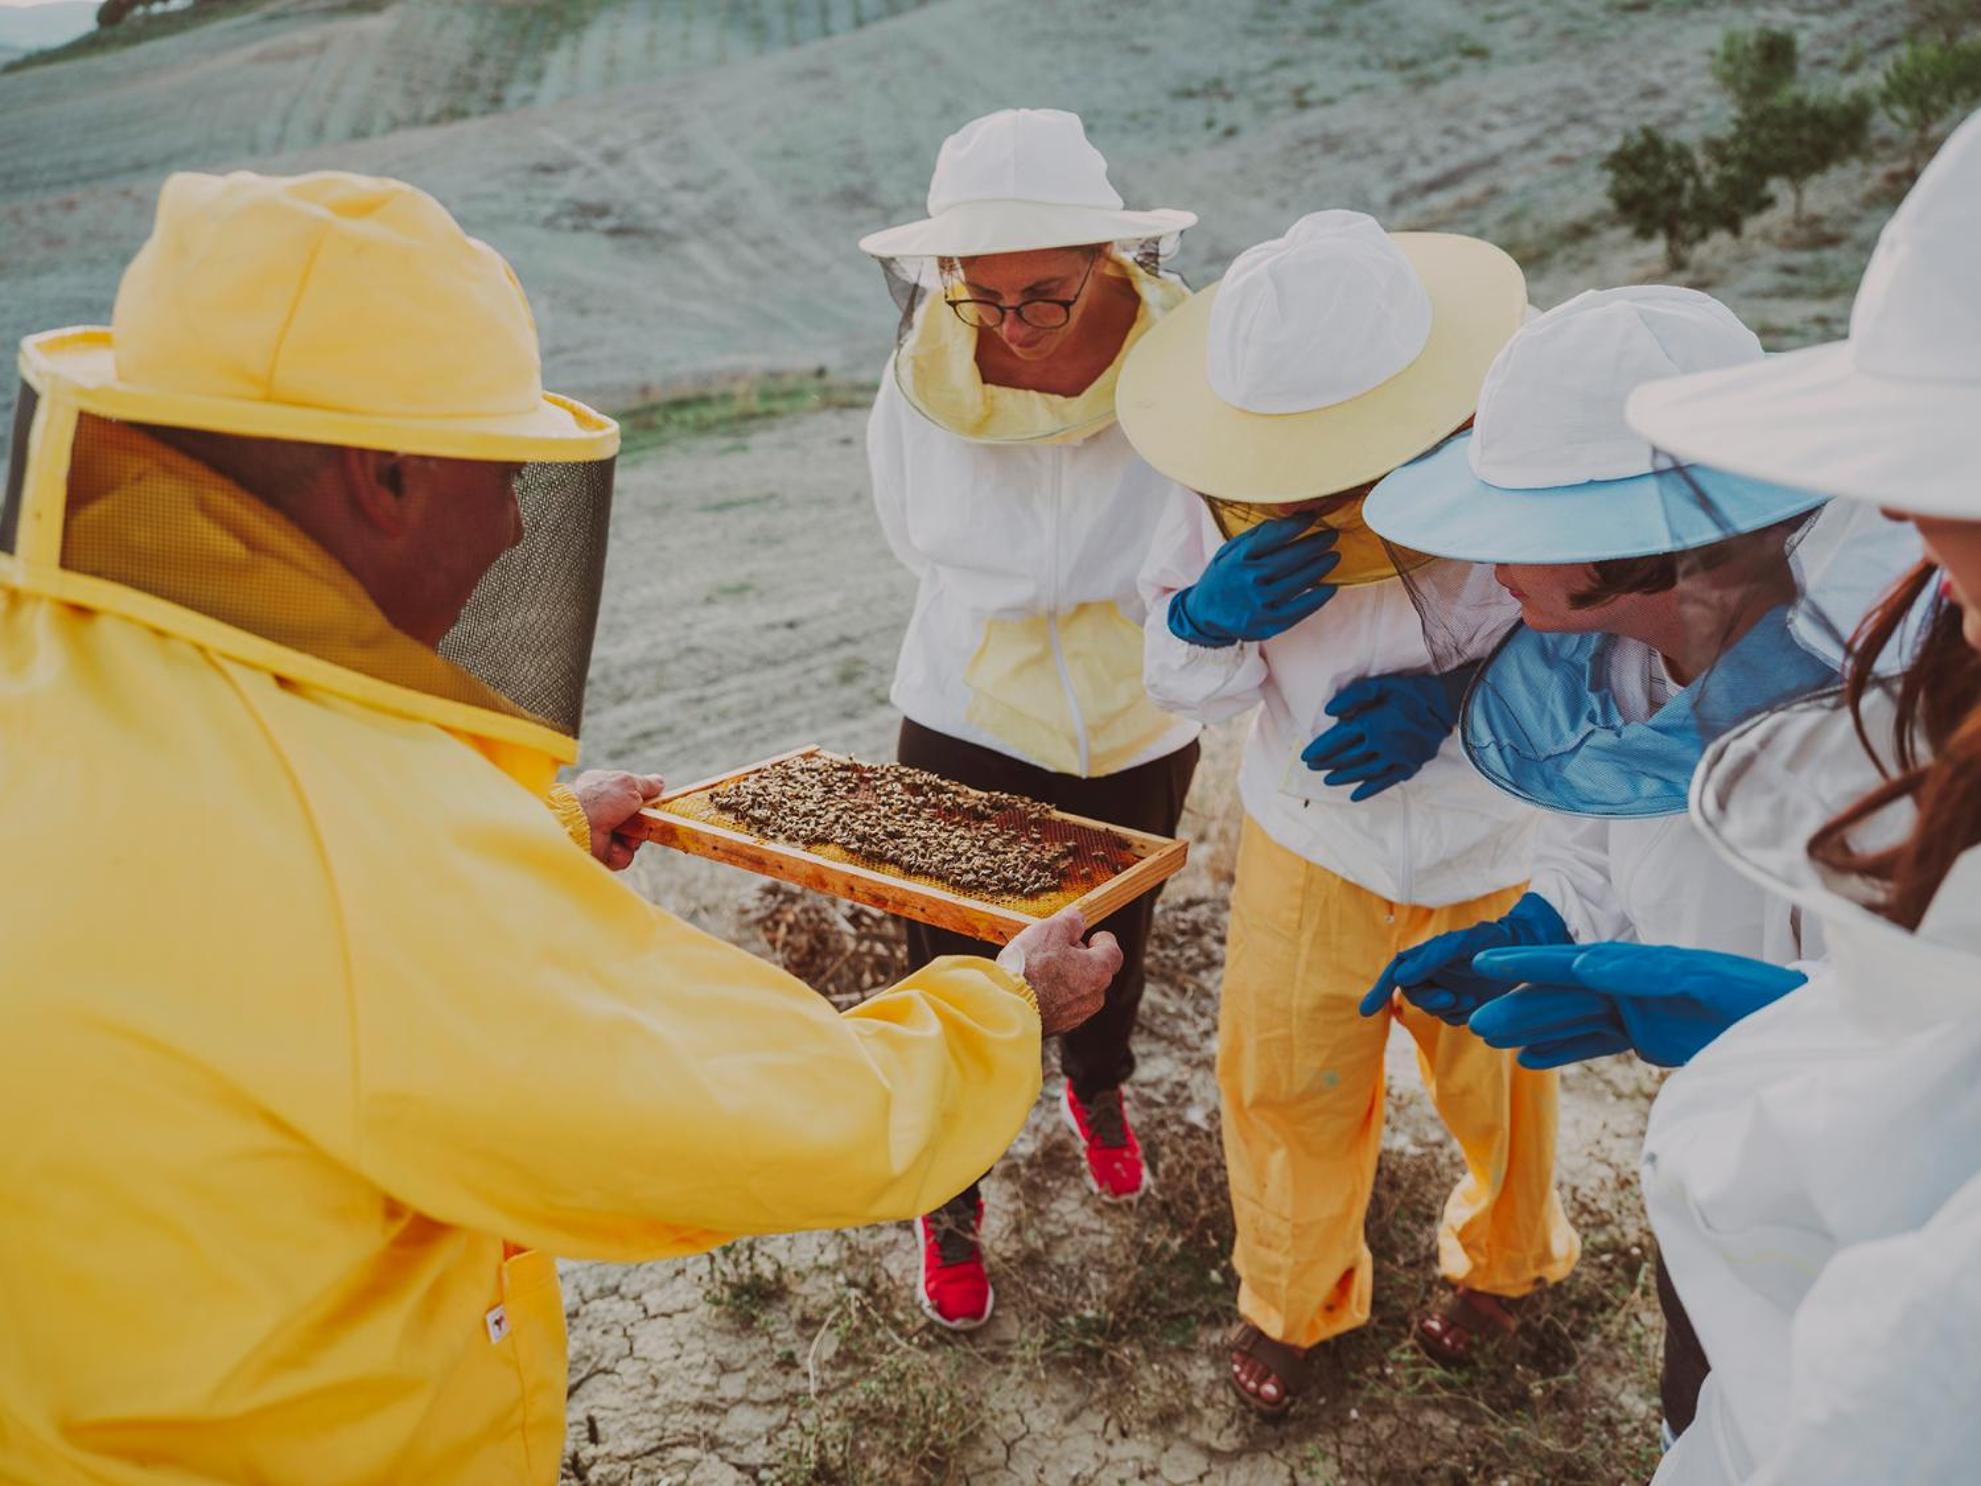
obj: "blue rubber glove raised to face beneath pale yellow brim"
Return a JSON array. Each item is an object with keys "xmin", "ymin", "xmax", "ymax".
[{"xmin": 1169, "ymin": 515, "xmax": 1341, "ymax": 650}]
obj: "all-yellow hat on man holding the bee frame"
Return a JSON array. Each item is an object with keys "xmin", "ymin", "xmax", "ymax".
[{"xmin": 22, "ymin": 170, "xmax": 618, "ymax": 464}]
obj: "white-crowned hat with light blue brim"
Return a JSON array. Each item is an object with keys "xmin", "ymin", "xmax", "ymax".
[{"xmin": 1365, "ymin": 283, "xmax": 1823, "ymax": 563}]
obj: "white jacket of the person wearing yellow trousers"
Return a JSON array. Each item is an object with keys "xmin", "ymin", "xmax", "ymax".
[{"xmin": 1141, "ymin": 487, "xmax": 1539, "ymax": 907}]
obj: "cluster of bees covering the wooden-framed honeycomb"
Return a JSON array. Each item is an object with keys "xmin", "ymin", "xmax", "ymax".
[{"xmin": 709, "ymin": 753, "xmax": 1078, "ymax": 898}]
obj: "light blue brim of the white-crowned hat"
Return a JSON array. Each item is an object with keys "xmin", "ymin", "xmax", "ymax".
[{"xmin": 1363, "ymin": 434, "xmax": 1825, "ymax": 563}]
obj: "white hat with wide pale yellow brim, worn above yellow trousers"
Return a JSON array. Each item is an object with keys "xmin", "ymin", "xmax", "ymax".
[{"xmin": 1115, "ymin": 212, "xmax": 1527, "ymax": 505}]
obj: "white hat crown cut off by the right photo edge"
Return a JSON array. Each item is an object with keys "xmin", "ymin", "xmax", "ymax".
[{"xmin": 1850, "ymin": 113, "xmax": 1981, "ymax": 382}]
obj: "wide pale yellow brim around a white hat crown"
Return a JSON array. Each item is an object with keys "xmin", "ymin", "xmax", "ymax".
[{"xmin": 1115, "ymin": 232, "xmax": 1527, "ymax": 505}]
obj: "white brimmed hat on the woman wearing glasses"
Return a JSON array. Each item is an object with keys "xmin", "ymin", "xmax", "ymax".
[{"xmin": 860, "ymin": 109, "xmax": 1197, "ymax": 258}]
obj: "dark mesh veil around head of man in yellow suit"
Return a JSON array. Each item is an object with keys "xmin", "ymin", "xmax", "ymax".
[{"xmin": 44, "ymin": 408, "xmax": 614, "ymax": 737}]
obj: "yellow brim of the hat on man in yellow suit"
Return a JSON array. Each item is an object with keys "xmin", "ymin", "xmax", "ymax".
[{"xmin": 20, "ymin": 325, "xmax": 618, "ymax": 464}]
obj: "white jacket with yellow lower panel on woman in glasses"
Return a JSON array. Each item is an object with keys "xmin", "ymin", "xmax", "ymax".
[{"xmin": 868, "ymin": 367, "xmax": 1199, "ymax": 779}]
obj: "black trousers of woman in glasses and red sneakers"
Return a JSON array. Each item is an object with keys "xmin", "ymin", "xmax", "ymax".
[{"xmin": 895, "ymin": 717, "xmax": 1200, "ymax": 1203}]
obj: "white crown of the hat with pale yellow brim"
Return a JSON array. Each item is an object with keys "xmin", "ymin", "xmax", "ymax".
[{"xmin": 1204, "ymin": 210, "xmax": 1430, "ymax": 414}]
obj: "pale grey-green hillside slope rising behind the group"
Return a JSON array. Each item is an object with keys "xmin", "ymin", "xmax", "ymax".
[{"xmin": 0, "ymin": 0, "xmax": 1904, "ymax": 447}]
